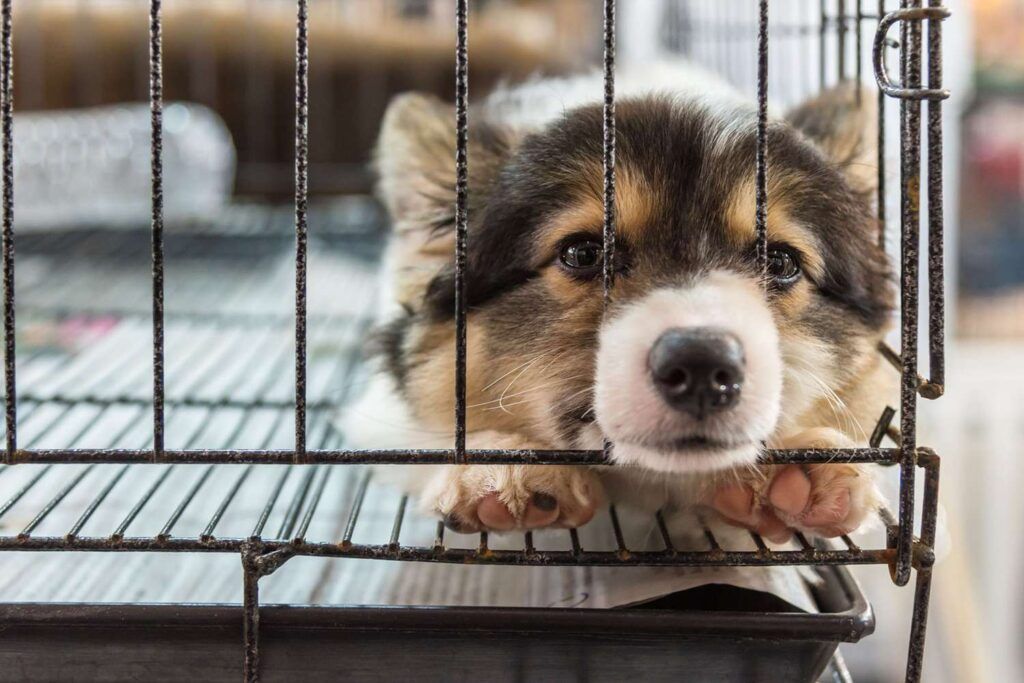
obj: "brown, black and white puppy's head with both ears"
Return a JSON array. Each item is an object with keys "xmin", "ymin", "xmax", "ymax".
[{"xmin": 379, "ymin": 87, "xmax": 891, "ymax": 472}]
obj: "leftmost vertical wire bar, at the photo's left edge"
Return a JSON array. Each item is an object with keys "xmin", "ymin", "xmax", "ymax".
[{"xmin": 0, "ymin": 0, "xmax": 17, "ymax": 464}]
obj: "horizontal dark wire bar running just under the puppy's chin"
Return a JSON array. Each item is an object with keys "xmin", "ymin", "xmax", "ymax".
[{"xmin": 8, "ymin": 447, "xmax": 900, "ymax": 465}]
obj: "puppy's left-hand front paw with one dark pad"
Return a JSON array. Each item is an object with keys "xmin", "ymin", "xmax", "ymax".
[{"xmin": 422, "ymin": 465, "xmax": 603, "ymax": 533}]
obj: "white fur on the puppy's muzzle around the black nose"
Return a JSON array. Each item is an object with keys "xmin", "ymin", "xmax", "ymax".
[{"xmin": 594, "ymin": 270, "xmax": 782, "ymax": 473}]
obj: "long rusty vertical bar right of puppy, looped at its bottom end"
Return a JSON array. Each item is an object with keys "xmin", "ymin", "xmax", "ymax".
[{"xmin": 893, "ymin": 0, "xmax": 921, "ymax": 586}]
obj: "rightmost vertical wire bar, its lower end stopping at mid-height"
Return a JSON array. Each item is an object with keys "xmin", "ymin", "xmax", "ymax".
[{"xmin": 923, "ymin": 0, "xmax": 946, "ymax": 398}]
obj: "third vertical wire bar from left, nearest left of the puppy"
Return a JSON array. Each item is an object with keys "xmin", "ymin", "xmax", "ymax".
[{"xmin": 295, "ymin": 0, "xmax": 309, "ymax": 462}]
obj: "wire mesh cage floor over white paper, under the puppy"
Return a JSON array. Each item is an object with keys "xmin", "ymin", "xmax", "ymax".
[{"xmin": 0, "ymin": 202, "xmax": 909, "ymax": 601}]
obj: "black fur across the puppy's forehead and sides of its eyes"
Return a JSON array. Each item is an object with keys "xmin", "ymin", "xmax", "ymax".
[{"xmin": 411, "ymin": 97, "xmax": 892, "ymax": 329}]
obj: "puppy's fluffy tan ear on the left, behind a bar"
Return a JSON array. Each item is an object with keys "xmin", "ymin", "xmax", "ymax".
[{"xmin": 375, "ymin": 93, "xmax": 512, "ymax": 310}]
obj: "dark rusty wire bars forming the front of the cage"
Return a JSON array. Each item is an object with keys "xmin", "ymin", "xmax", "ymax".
[{"xmin": 0, "ymin": 0, "xmax": 949, "ymax": 681}]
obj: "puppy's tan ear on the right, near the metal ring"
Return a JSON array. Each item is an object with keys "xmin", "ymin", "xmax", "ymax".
[{"xmin": 785, "ymin": 83, "xmax": 879, "ymax": 194}]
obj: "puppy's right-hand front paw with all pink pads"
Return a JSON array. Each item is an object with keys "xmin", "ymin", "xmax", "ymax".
[{"xmin": 710, "ymin": 428, "xmax": 883, "ymax": 543}]
